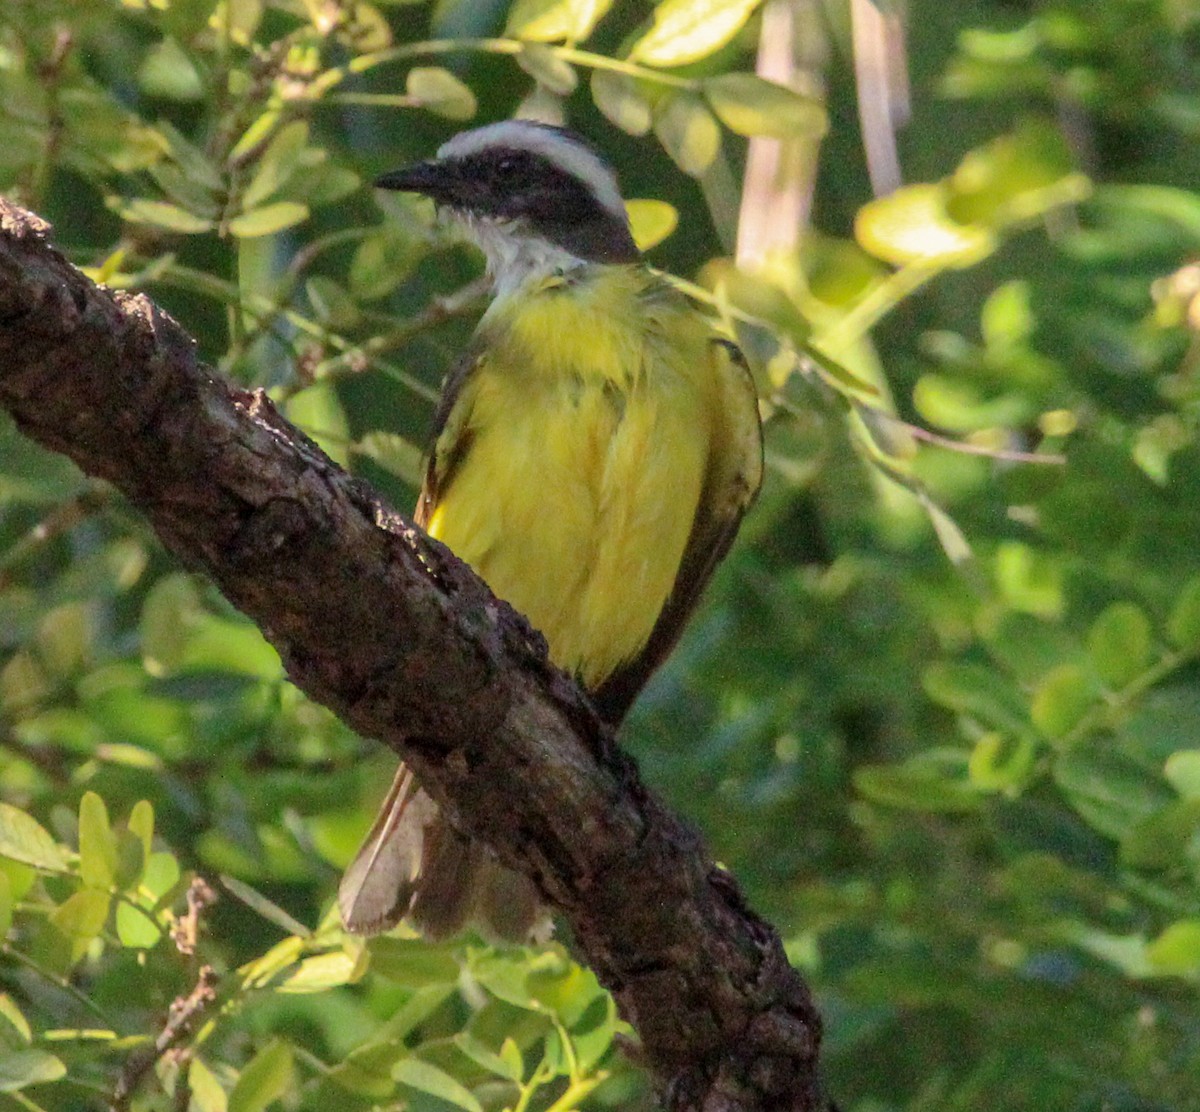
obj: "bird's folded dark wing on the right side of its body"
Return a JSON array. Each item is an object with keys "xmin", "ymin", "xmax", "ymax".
[{"xmin": 593, "ymin": 339, "xmax": 762, "ymax": 725}]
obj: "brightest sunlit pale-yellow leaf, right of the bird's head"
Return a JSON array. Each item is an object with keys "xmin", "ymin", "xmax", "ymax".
[{"xmin": 854, "ymin": 185, "xmax": 996, "ymax": 269}]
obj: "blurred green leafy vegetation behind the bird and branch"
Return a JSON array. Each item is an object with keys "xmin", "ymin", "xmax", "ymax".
[{"xmin": 0, "ymin": 0, "xmax": 1200, "ymax": 1112}]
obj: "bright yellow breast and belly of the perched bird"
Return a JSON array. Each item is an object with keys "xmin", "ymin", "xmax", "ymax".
[{"xmin": 428, "ymin": 272, "xmax": 710, "ymax": 687}]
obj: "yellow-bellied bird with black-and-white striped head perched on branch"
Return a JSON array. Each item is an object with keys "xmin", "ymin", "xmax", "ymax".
[{"xmin": 338, "ymin": 119, "xmax": 763, "ymax": 940}]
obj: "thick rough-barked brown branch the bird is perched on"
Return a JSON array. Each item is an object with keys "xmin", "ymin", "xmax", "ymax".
[{"xmin": 0, "ymin": 200, "xmax": 823, "ymax": 1112}]
